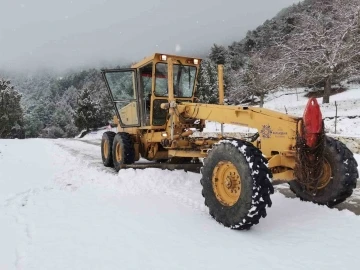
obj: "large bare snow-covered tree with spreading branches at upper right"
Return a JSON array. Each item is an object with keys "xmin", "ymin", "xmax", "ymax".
[{"xmin": 277, "ymin": 0, "xmax": 360, "ymax": 103}]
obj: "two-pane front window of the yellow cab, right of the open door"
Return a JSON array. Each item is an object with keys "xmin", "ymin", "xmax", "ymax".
[{"xmin": 155, "ymin": 63, "xmax": 196, "ymax": 98}]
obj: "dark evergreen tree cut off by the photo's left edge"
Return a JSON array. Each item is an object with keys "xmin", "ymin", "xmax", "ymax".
[{"xmin": 0, "ymin": 79, "xmax": 23, "ymax": 138}]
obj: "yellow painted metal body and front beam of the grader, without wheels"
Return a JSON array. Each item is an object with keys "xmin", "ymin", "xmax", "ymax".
[{"xmin": 107, "ymin": 53, "xmax": 301, "ymax": 180}]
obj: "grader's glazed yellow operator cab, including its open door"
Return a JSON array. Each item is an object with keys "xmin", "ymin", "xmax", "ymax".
[{"xmin": 102, "ymin": 54, "xmax": 201, "ymax": 128}]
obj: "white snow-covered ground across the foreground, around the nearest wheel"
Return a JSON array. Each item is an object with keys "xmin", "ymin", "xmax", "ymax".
[{"xmin": 0, "ymin": 139, "xmax": 360, "ymax": 270}]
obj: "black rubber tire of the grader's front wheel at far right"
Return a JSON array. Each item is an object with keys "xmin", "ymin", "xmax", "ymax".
[{"xmin": 289, "ymin": 137, "xmax": 359, "ymax": 207}]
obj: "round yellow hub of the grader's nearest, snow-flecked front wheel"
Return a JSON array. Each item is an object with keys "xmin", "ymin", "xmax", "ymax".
[{"xmin": 212, "ymin": 161, "xmax": 241, "ymax": 206}]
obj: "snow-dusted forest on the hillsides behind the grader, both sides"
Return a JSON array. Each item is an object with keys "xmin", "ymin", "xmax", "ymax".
[{"xmin": 0, "ymin": 0, "xmax": 360, "ymax": 138}]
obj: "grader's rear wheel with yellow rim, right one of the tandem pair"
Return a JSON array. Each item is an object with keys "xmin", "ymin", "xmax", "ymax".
[{"xmin": 112, "ymin": 132, "xmax": 135, "ymax": 171}]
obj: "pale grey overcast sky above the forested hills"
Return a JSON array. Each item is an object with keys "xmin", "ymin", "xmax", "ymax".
[{"xmin": 0, "ymin": 0, "xmax": 299, "ymax": 70}]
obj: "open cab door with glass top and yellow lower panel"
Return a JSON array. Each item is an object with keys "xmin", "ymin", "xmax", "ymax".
[{"xmin": 101, "ymin": 68, "xmax": 140, "ymax": 128}]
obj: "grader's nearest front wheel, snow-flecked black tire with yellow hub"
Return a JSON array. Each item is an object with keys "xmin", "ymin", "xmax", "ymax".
[{"xmin": 200, "ymin": 139, "xmax": 274, "ymax": 230}]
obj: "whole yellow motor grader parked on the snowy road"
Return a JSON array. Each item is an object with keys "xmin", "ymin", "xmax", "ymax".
[{"xmin": 101, "ymin": 53, "xmax": 358, "ymax": 230}]
